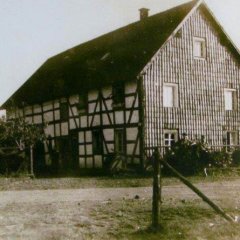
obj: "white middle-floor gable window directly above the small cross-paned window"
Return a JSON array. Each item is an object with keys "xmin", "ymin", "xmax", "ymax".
[{"xmin": 163, "ymin": 83, "xmax": 178, "ymax": 107}]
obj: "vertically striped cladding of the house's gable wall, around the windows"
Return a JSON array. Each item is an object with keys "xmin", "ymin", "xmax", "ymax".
[{"xmin": 143, "ymin": 9, "xmax": 240, "ymax": 158}]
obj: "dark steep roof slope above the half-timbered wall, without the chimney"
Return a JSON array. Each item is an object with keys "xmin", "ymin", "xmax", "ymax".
[{"xmin": 2, "ymin": 1, "xmax": 199, "ymax": 107}]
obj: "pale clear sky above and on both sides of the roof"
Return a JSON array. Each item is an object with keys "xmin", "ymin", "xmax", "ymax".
[{"xmin": 0, "ymin": 0, "xmax": 240, "ymax": 108}]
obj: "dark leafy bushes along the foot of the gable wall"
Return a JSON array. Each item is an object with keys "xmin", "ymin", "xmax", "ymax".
[{"xmin": 165, "ymin": 139, "xmax": 236, "ymax": 176}]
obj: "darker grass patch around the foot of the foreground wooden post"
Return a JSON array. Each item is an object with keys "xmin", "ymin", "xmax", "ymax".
[{"xmin": 92, "ymin": 199, "xmax": 240, "ymax": 240}]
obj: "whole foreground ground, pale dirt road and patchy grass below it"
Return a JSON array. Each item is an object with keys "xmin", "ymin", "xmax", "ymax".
[{"xmin": 0, "ymin": 180, "xmax": 240, "ymax": 240}]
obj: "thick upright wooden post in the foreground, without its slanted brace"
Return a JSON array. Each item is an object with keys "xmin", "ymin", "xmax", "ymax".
[{"xmin": 152, "ymin": 148, "xmax": 161, "ymax": 229}]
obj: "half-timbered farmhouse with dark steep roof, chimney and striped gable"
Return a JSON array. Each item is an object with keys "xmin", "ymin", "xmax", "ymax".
[{"xmin": 2, "ymin": 1, "xmax": 240, "ymax": 172}]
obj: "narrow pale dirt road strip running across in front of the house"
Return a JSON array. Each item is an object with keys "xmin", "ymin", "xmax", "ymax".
[{"xmin": 0, "ymin": 180, "xmax": 240, "ymax": 205}]
